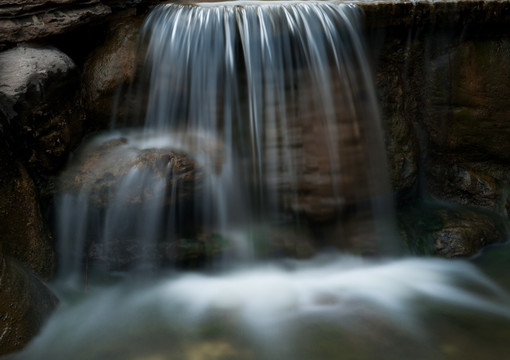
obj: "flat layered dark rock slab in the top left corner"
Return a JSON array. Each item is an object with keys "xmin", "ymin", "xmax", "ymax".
[{"xmin": 0, "ymin": 0, "xmax": 111, "ymax": 45}]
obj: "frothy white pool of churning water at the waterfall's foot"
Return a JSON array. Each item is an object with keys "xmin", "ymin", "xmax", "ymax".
[{"xmin": 15, "ymin": 256, "xmax": 510, "ymax": 360}]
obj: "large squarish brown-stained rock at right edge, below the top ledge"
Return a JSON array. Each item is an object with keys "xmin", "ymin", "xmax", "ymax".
[{"xmin": 425, "ymin": 40, "xmax": 510, "ymax": 162}]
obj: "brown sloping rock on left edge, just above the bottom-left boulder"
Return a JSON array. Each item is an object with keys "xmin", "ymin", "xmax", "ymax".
[{"xmin": 0, "ymin": 149, "xmax": 55, "ymax": 279}]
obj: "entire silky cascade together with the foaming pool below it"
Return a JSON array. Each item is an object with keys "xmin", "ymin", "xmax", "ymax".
[{"xmin": 15, "ymin": 1, "xmax": 510, "ymax": 360}]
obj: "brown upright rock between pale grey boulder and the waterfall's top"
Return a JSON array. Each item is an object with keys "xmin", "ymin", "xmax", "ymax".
[{"xmin": 83, "ymin": 17, "xmax": 143, "ymax": 129}]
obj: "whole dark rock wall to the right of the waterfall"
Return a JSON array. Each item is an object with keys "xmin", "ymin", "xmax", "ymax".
[{"xmin": 368, "ymin": 9, "xmax": 510, "ymax": 257}]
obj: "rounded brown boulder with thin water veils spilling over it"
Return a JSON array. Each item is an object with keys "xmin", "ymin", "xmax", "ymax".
[{"xmin": 60, "ymin": 137, "xmax": 201, "ymax": 207}]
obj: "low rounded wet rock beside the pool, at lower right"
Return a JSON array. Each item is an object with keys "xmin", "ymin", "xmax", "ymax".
[{"xmin": 432, "ymin": 209, "xmax": 506, "ymax": 258}]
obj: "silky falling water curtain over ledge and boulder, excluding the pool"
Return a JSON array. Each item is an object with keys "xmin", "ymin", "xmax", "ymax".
[{"xmin": 59, "ymin": 2, "xmax": 396, "ymax": 273}]
